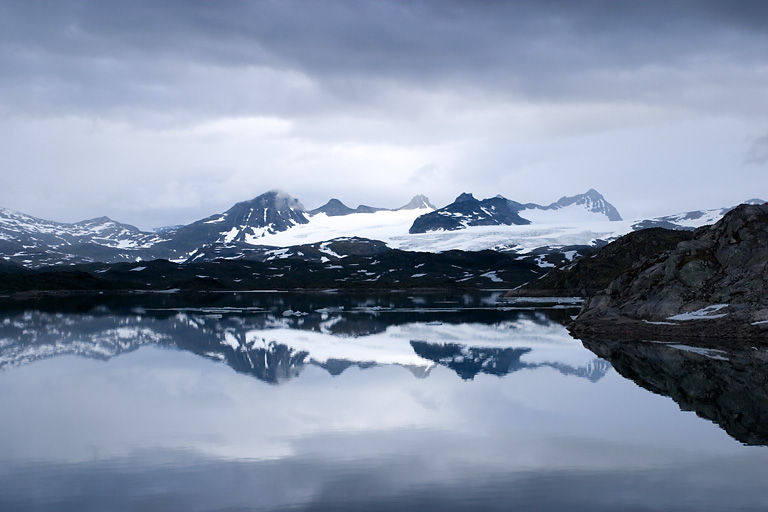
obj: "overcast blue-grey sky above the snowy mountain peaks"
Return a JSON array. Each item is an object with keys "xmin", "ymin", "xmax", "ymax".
[{"xmin": 0, "ymin": 0, "xmax": 768, "ymax": 229}]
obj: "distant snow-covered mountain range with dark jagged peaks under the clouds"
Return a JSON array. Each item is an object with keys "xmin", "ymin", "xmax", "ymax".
[{"xmin": 0, "ymin": 189, "xmax": 756, "ymax": 274}]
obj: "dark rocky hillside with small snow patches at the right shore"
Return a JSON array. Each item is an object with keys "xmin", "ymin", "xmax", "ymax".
[{"xmin": 574, "ymin": 204, "xmax": 768, "ymax": 338}]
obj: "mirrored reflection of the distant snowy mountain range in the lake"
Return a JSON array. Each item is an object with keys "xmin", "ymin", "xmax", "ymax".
[{"xmin": 0, "ymin": 296, "xmax": 610, "ymax": 383}]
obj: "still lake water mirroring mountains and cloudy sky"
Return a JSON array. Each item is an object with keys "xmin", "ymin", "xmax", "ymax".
[{"xmin": 0, "ymin": 293, "xmax": 768, "ymax": 511}]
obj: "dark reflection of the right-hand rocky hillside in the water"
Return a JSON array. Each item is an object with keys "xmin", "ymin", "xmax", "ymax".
[{"xmin": 583, "ymin": 339, "xmax": 768, "ymax": 445}]
